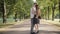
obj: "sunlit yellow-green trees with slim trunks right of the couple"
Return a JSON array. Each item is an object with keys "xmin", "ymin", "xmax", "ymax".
[{"xmin": 37, "ymin": 0, "xmax": 59, "ymax": 21}]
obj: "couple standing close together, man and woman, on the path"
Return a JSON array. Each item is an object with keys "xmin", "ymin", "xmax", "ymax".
[{"xmin": 30, "ymin": 3, "xmax": 41, "ymax": 34}]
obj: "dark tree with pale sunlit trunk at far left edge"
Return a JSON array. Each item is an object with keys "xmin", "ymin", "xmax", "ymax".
[{"xmin": 0, "ymin": 0, "xmax": 6, "ymax": 23}]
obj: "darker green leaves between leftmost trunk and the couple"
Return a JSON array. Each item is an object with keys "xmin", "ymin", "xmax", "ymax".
[{"xmin": 5, "ymin": 0, "xmax": 33, "ymax": 17}]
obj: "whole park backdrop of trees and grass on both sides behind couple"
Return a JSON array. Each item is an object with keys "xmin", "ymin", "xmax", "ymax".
[{"xmin": 0, "ymin": 0, "xmax": 60, "ymax": 28}]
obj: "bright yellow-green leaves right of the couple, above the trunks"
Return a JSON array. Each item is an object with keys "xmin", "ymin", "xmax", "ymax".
[{"xmin": 37, "ymin": 0, "xmax": 59, "ymax": 19}]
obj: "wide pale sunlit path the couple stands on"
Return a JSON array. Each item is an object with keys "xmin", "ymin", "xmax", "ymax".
[{"xmin": 0, "ymin": 20, "xmax": 60, "ymax": 34}]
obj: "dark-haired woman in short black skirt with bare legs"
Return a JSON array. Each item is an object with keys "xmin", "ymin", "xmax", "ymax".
[{"xmin": 33, "ymin": 5, "xmax": 41, "ymax": 33}]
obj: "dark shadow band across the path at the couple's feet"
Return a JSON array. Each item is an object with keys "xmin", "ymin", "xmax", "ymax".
[{"xmin": 0, "ymin": 30, "xmax": 60, "ymax": 34}]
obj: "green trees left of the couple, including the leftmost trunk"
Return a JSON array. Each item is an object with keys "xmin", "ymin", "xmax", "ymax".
[{"xmin": 0, "ymin": 0, "xmax": 33, "ymax": 23}]
